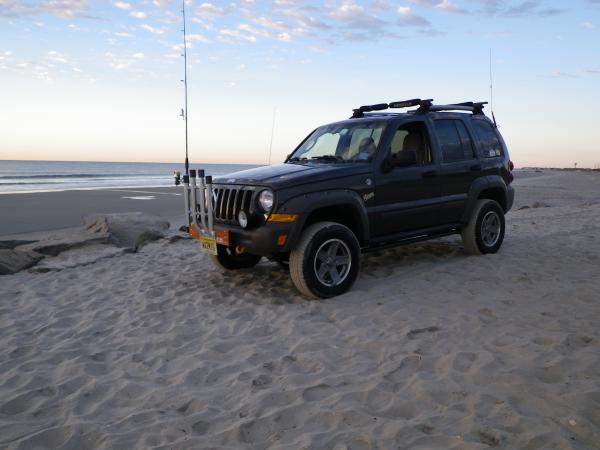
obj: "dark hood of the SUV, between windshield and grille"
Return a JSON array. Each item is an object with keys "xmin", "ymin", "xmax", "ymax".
[{"xmin": 214, "ymin": 163, "xmax": 371, "ymax": 188}]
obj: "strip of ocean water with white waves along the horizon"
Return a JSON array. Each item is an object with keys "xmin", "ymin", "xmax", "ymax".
[{"xmin": 0, "ymin": 160, "xmax": 257, "ymax": 194}]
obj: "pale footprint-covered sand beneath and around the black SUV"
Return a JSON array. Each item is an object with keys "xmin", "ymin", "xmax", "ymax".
[{"xmin": 0, "ymin": 172, "xmax": 600, "ymax": 450}]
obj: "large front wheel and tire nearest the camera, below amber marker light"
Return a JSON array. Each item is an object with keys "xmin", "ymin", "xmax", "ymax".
[{"xmin": 290, "ymin": 222, "xmax": 360, "ymax": 299}]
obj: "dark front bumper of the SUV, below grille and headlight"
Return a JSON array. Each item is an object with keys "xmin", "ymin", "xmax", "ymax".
[{"xmin": 214, "ymin": 222, "xmax": 296, "ymax": 256}]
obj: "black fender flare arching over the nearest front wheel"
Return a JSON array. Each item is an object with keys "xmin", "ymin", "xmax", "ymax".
[{"xmin": 277, "ymin": 189, "xmax": 370, "ymax": 247}]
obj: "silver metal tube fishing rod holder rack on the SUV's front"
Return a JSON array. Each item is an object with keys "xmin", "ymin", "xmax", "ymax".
[{"xmin": 183, "ymin": 169, "xmax": 215, "ymax": 238}]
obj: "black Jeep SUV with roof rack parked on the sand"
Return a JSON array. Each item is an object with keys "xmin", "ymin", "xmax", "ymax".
[{"xmin": 205, "ymin": 99, "xmax": 514, "ymax": 298}]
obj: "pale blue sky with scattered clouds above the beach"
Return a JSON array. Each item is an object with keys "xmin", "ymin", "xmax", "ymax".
[{"xmin": 0, "ymin": 0, "xmax": 600, "ymax": 167}]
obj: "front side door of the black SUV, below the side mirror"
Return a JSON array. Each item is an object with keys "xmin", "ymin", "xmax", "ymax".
[{"xmin": 372, "ymin": 119, "xmax": 441, "ymax": 237}]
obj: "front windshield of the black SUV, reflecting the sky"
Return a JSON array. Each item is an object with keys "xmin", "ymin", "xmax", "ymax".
[{"xmin": 288, "ymin": 122, "xmax": 386, "ymax": 162}]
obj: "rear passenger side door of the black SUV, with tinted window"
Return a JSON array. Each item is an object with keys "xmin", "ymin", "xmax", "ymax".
[{"xmin": 433, "ymin": 118, "xmax": 482, "ymax": 224}]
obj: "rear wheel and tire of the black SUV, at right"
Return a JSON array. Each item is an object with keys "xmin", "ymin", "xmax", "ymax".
[{"xmin": 461, "ymin": 199, "xmax": 505, "ymax": 255}]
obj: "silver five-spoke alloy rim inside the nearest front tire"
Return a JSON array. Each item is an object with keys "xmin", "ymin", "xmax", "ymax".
[{"xmin": 314, "ymin": 239, "xmax": 352, "ymax": 287}]
